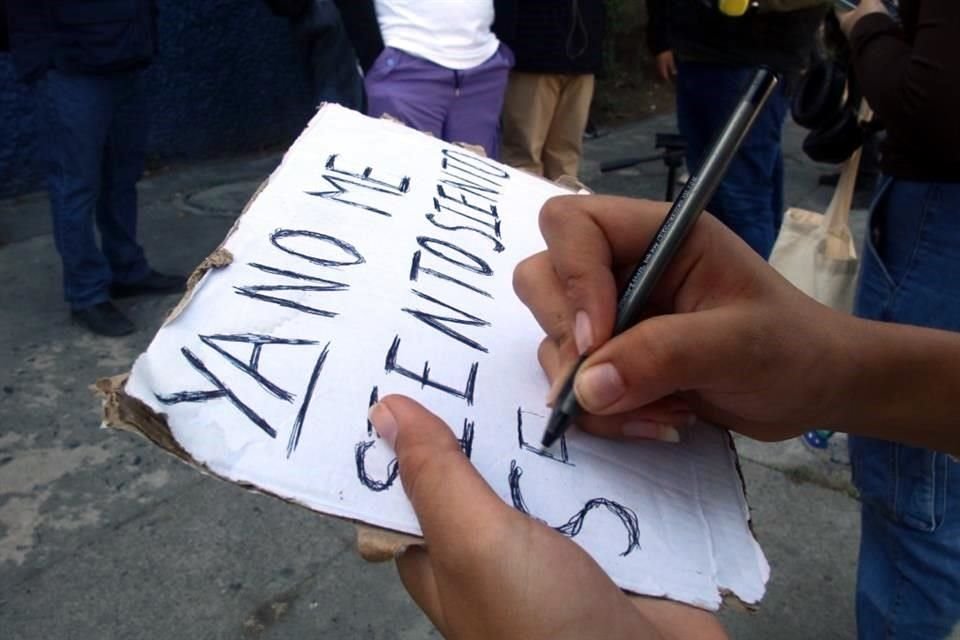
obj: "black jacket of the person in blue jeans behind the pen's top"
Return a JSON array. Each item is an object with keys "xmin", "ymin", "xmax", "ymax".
[{"xmin": 647, "ymin": 0, "xmax": 826, "ymax": 73}]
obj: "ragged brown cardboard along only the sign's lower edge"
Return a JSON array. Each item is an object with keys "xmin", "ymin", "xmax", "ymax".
[{"xmin": 93, "ymin": 376, "xmax": 757, "ymax": 613}]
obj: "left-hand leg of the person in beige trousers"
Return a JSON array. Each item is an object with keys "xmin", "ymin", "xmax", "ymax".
[{"xmin": 500, "ymin": 71, "xmax": 560, "ymax": 176}]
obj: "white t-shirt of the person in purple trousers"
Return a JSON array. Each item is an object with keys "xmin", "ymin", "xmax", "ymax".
[{"xmin": 375, "ymin": 0, "xmax": 500, "ymax": 69}]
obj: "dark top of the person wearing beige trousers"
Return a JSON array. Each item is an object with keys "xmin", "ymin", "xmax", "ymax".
[{"xmin": 498, "ymin": 0, "xmax": 607, "ymax": 74}]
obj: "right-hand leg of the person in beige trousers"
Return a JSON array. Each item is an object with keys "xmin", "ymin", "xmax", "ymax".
[{"xmin": 543, "ymin": 75, "xmax": 593, "ymax": 180}]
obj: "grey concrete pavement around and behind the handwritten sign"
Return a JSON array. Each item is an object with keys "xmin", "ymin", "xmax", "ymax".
[{"xmin": 0, "ymin": 117, "xmax": 862, "ymax": 640}]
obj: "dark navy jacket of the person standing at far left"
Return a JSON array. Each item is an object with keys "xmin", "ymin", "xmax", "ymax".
[{"xmin": 7, "ymin": 0, "xmax": 157, "ymax": 81}]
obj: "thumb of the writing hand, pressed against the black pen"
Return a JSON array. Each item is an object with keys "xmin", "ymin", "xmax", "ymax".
[{"xmin": 574, "ymin": 307, "xmax": 761, "ymax": 415}]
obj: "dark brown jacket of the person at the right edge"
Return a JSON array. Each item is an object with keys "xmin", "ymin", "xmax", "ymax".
[{"xmin": 850, "ymin": 0, "xmax": 960, "ymax": 182}]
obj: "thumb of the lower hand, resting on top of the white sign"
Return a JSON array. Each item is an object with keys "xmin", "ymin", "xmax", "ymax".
[{"xmin": 370, "ymin": 395, "xmax": 513, "ymax": 557}]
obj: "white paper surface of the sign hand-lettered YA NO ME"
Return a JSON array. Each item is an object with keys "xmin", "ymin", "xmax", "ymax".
[{"xmin": 126, "ymin": 106, "xmax": 769, "ymax": 609}]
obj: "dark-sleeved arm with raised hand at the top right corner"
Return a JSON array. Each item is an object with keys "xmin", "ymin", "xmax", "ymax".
[{"xmin": 841, "ymin": 0, "xmax": 960, "ymax": 150}]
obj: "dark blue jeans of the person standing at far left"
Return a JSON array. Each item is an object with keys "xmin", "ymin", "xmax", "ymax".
[{"xmin": 43, "ymin": 70, "xmax": 149, "ymax": 309}]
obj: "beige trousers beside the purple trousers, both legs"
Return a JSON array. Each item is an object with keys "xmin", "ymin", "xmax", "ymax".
[{"xmin": 501, "ymin": 71, "xmax": 593, "ymax": 180}]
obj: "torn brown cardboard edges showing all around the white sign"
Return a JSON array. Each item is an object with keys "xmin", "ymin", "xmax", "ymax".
[{"xmin": 101, "ymin": 105, "xmax": 758, "ymax": 613}]
